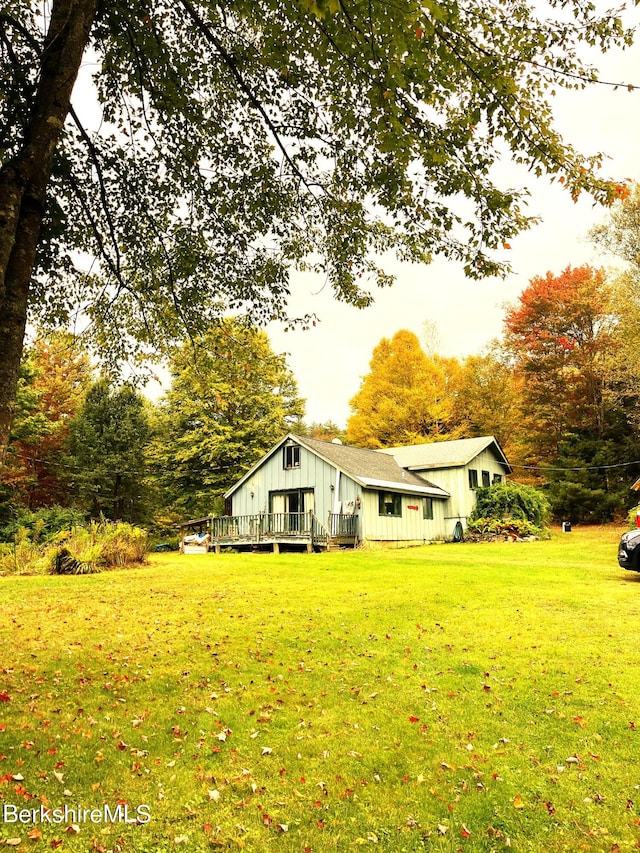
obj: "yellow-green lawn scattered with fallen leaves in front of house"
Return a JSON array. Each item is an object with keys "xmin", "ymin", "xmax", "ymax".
[{"xmin": 0, "ymin": 528, "xmax": 640, "ymax": 853}]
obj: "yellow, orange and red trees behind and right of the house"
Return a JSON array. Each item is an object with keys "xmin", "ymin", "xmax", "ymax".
[{"xmin": 347, "ymin": 186, "xmax": 640, "ymax": 521}]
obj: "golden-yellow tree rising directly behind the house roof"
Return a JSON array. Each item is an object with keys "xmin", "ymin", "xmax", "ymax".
[{"xmin": 347, "ymin": 329, "xmax": 460, "ymax": 447}]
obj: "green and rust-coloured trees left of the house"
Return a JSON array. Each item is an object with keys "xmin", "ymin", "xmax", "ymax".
[{"xmin": 0, "ymin": 320, "xmax": 304, "ymax": 533}]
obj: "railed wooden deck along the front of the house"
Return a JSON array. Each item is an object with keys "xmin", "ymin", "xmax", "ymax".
[{"xmin": 180, "ymin": 512, "xmax": 358, "ymax": 553}]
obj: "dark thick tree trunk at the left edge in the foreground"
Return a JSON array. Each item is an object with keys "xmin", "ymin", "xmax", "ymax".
[{"xmin": 0, "ymin": 0, "xmax": 98, "ymax": 467}]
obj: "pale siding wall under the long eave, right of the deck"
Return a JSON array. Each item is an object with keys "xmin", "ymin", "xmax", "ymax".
[{"xmin": 362, "ymin": 489, "xmax": 453, "ymax": 542}]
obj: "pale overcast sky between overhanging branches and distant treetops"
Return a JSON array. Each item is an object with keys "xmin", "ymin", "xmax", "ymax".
[{"xmin": 268, "ymin": 22, "xmax": 640, "ymax": 426}]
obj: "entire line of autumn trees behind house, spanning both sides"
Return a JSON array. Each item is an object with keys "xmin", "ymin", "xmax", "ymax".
[{"xmin": 5, "ymin": 187, "xmax": 640, "ymax": 531}]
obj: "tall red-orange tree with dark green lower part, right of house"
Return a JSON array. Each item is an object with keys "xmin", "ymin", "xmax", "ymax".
[{"xmin": 504, "ymin": 266, "xmax": 640, "ymax": 520}]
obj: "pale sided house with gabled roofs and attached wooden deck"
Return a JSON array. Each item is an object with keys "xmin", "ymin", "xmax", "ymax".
[{"xmin": 181, "ymin": 433, "xmax": 511, "ymax": 551}]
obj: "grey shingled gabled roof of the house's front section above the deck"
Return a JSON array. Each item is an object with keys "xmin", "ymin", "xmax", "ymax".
[{"xmin": 225, "ymin": 433, "xmax": 449, "ymax": 498}]
